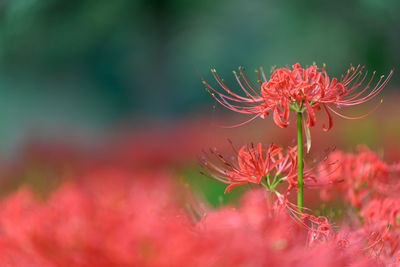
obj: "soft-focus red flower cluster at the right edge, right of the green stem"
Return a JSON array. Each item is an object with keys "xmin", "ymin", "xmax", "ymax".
[{"xmin": 318, "ymin": 146, "xmax": 400, "ymax": 207}]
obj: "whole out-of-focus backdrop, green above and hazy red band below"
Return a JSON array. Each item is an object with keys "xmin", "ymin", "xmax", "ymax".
[{"xmin": 0, "ymin": 0, "xmax": 400, "ymax": 206}]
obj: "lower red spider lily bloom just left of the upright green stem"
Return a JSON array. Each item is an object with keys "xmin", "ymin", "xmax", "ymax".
[{"xmin": 201, "ymin": 143, "xmax": 296, "ymax": 192}]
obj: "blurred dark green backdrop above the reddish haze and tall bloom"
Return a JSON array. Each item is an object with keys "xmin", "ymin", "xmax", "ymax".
[{"xmin": 0, "ymin": 0, "xmax": 400, "ymax": 150}]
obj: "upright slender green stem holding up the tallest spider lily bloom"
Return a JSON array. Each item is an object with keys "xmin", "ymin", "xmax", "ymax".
[{"xmin": 297, "ymin": 112, "xmax": 304, "ymax": 211}]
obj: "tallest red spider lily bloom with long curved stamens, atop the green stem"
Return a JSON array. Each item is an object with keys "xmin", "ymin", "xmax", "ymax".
[{"xmin": 203, "ymin": 63, "xmax": 393, "ymax": 130}]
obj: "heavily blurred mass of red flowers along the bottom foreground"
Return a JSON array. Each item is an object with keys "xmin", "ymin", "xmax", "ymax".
[{"xmin": 0, "ymin": 173, "xmax": 384, "ymax": 266}]
